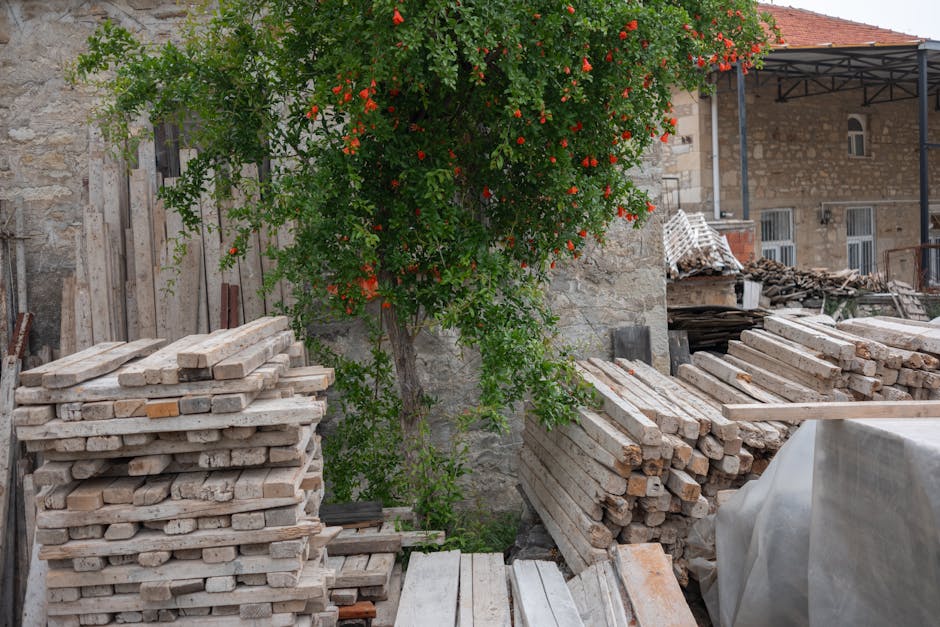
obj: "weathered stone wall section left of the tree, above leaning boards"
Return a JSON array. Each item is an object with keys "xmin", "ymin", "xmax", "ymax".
[{"xmin": 0, "ymin": 0, "xmax": 185, "ymax": 349}]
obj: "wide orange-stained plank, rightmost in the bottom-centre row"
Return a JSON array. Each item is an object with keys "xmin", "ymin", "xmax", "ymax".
[{"xmin": 612, "ymin": 543, "xmax": 697, "ymax": 627}]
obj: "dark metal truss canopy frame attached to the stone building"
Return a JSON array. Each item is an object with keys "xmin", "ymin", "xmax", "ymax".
[{"xmin": 755, "ymin": 41, "xmax": 940, "ymax": 105}]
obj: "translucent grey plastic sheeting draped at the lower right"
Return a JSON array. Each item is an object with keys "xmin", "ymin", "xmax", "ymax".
[{"xmin": 703, "ymin": 420, "xmax": 940, "ymax": 627}]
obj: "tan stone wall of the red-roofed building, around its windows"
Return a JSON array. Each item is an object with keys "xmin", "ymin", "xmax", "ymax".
[{"xmin": 664, "ymin": 70, "xmax": 940, "ymax": 276}]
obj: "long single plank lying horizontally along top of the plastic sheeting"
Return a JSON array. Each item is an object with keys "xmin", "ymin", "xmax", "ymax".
[{"xmin": 724, "ymin": 401, "xmax": 940, "ymax": 422}]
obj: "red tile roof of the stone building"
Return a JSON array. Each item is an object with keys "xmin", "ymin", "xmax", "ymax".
[{"xmin": 758, "ymin": 4, "xmax": 924, "ymax": 48}]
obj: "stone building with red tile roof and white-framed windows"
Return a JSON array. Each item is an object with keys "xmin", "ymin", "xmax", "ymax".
[{"xmin": 663, "ymin": 5, "xmax": 940, "ymax": 282}]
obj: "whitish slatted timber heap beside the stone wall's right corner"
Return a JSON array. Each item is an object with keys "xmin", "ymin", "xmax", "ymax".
[{"xmin": 663, "ymin": 209, "xmax": 741, "ymax": 279}]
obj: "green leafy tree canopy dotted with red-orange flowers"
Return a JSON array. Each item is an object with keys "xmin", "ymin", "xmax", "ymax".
[{"xmin": 74, "ymin": 0, "xmax": 767, "ymax": 427}]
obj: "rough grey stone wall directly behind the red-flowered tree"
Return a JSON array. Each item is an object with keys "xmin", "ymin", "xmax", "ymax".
[{"xmin": 0, "ymin": 0, "xmax": 668, "ymax": 507}]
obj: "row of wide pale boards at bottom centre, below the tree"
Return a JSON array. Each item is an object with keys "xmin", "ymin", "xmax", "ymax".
[{"xmin": 392, "ymin": 544, "xmax": 696, "ymax": 627}]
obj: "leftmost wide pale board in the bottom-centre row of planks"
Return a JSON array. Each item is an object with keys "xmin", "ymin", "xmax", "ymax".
[{"xmin": 395, "ymin": 551, "xmax": 460, "ymax": 627}]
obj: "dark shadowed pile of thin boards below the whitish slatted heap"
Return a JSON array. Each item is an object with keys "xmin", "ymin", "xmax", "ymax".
[{"xmin": 667, "ymin": 305, "xmax": 767, "ymax": 351}]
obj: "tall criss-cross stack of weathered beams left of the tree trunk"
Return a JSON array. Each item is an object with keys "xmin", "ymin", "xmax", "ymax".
[{"xmin": 14, "ymin": 317, "xmax": 340, "ymax": 626}]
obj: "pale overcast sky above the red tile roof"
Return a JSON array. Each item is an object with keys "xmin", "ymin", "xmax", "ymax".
[{"xmin": 760, "ymin": 0, "xmax": 940, "ymax": 41}]
